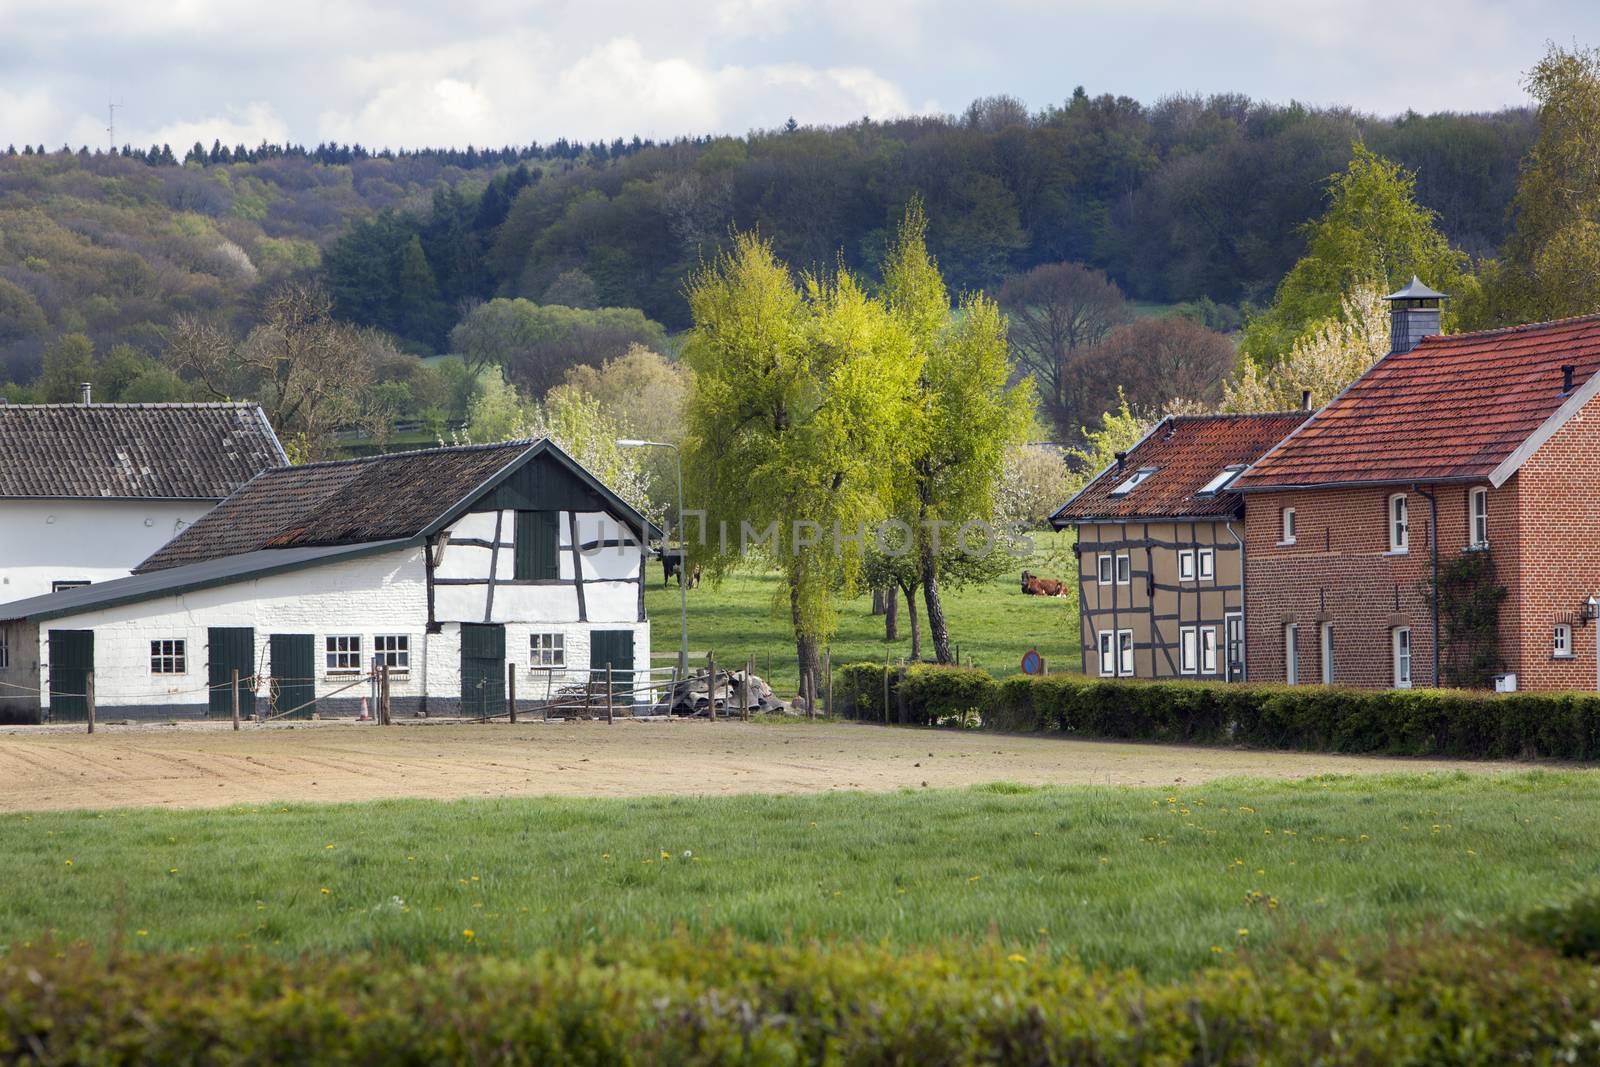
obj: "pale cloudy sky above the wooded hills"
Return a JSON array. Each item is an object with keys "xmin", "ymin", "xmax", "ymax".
[{"xmin": 0, "ymin": 0, "xmax": 1600, "ymax": 152}]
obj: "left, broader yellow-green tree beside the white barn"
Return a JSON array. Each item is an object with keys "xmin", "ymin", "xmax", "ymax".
[{"xmin": 683, "ymin": 234, "xmax": 920, "ymax": 678}]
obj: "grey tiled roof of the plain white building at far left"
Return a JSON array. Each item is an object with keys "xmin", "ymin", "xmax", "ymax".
[{"xmin": 0, "ymin": 403, "xmax": 288, "ymax": 501}]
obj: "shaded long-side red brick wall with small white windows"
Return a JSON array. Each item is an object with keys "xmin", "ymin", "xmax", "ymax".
[{"xmin": 1245, "ymin": 485, "xmax": 1517, "ymax": 688}]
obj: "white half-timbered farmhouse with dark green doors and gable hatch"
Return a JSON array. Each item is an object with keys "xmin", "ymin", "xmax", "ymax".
[{"xmin": 0, "ymin": 442, "xmax": 650, "ymax": 721}]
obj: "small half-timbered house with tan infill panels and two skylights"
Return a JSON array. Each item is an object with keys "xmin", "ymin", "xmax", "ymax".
[{"xmin": 1051, "ymin": 411, "xmax": 1309, "ymax": 680}]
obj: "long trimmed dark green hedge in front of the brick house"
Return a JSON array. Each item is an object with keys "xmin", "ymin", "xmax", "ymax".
[{"xmin": 835, "ymin": 664, "xmax": 1600, "ymax": 760}]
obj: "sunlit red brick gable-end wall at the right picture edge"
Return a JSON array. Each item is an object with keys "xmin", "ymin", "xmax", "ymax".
[{"xmin": 1501, "ymin": 390, "xmax": 1600, "ymax": 689}]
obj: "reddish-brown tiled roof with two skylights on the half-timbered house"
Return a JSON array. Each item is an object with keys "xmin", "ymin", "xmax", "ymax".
[{"xmin": 1051, "ymin": 411, "xmax": 1307, "ymax": 526}]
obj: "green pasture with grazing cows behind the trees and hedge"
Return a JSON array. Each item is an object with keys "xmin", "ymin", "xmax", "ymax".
[{"xmin": 645, "ymin": 531, "xmax": 1078, "ymax": 696}]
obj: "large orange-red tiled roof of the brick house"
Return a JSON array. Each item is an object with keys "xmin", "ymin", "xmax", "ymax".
[{"xmin": 1237, "ymin": 315, "xmax": 1600, "ymax": 491}]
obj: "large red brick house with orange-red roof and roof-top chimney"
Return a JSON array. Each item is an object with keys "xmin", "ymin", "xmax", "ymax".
[{"xmin": 1234, "ymin": 280, "xmax": 1600, "ymax": 689}]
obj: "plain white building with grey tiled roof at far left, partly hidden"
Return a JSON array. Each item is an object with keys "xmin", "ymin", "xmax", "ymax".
[{"xmin": 0, "ymin": 403, "xmax": 288, "ymax": 601}]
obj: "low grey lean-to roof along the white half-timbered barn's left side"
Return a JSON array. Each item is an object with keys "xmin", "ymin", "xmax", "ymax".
[{"xmin": 0, "ymin": 539, "xmax": 408, "ymax": 622}]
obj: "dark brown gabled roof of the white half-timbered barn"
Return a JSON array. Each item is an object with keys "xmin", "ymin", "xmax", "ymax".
[{"xmin": 134, "ymin": 440, "xmax": 648, "ymax": 574}]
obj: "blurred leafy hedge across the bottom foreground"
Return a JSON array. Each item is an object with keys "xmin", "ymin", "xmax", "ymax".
[{"xmin": 0, "ymin": 937, "xmax": 1600, "ymax": 1067}]
